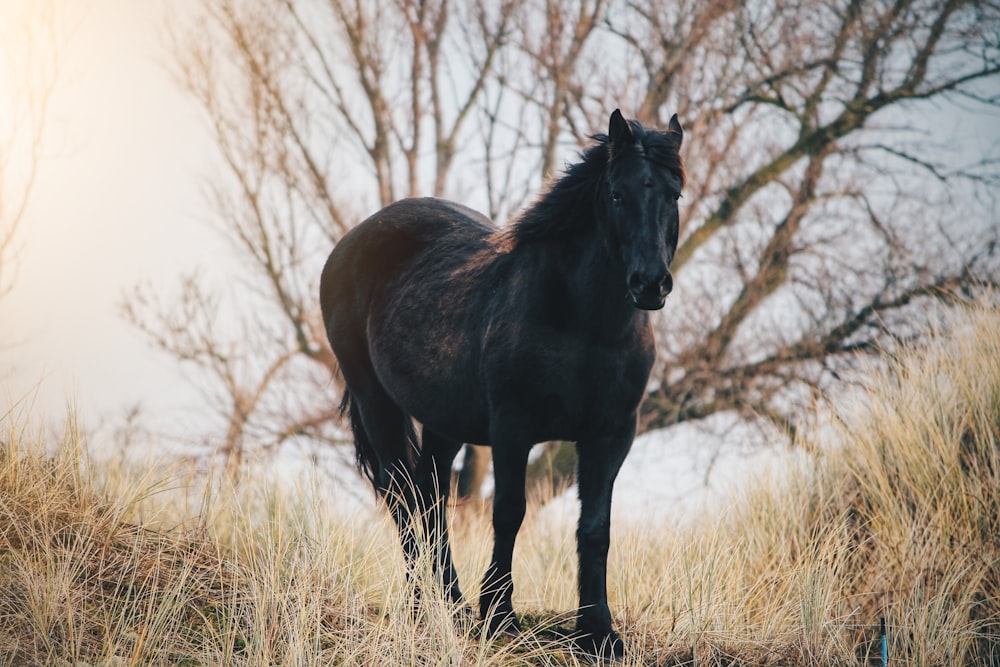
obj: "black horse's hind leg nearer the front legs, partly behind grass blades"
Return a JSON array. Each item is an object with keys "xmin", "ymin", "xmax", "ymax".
[{"xmin": 416, "ymin": 427, "xmax": 463, "ymax": 603}]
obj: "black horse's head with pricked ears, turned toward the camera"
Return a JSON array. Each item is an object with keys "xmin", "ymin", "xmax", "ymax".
[{"xmin": 606, "ymin": 109, "xmax": 684, "ymax": 310}]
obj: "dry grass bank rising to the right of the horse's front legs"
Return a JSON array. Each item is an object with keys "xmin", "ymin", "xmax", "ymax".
[{"xmin": 612, "ymin": 306, "xmax": 1000, "ymax": 667}]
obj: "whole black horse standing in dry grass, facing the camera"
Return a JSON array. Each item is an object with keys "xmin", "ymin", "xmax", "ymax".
[{"xmin": 320, "ymin": 110, "xmax": 684, "ymax": 657}]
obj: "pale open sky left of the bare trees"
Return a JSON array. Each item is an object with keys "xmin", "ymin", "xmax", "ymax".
[{"xmin": 0, "ymin": 0, "xmax": 222, "ymax": 436}]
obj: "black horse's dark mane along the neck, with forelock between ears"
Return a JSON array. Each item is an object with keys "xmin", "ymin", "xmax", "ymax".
[{"xmin": 500, "ymin": 120, "xmax": 684, "ymax": 249}]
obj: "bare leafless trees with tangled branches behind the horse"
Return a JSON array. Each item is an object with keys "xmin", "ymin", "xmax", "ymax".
[{"xmin": 126, "ymin": 0, "xmax": 1000, "ymax": 488}]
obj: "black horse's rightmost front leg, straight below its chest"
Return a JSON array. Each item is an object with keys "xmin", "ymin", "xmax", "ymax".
[{"xmin": 576, "ymin": 418, "xmax": 635, "ymax": 659}]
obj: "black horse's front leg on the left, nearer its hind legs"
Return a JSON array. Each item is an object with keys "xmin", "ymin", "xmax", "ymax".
[{"xmin": 479, "ymin": 438, "xmax": 531, "ymax": 635}]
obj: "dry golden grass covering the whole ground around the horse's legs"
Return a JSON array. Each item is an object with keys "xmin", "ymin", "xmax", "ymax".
[{"xmin": 0, "ymin": 307, "xmax": 1000, "ymax": 666}]
